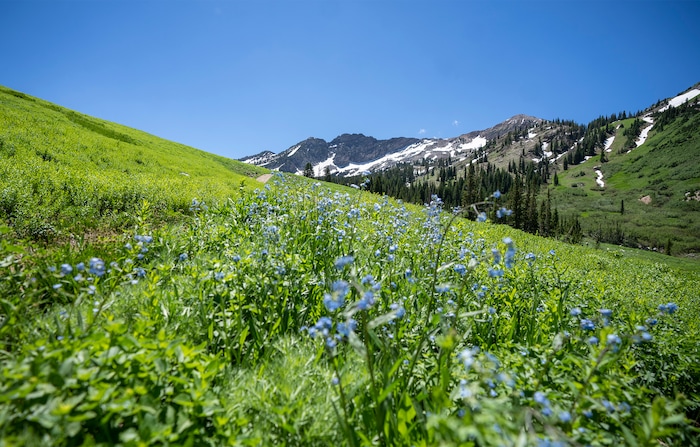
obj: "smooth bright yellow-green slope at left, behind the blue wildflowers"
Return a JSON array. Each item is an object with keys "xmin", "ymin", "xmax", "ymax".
[{"xmin": 0, "ymin": 87, "xmax": 266, "ymax": 240}]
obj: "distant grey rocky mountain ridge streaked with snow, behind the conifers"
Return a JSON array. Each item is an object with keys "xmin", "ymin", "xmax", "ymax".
[{"xmin": 240, "ymin": 115, "xmax": 545, "ymax": 176}]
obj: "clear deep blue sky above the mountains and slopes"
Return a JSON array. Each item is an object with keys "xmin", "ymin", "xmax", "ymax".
[{"xmin": 0, "ymin": 0, "xmax": 700, "ymax": 158}]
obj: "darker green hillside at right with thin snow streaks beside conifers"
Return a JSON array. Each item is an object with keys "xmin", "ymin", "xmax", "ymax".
[{"xmin": 553, "ymin": 104, "xmax": 700, "ymax": 256}]
